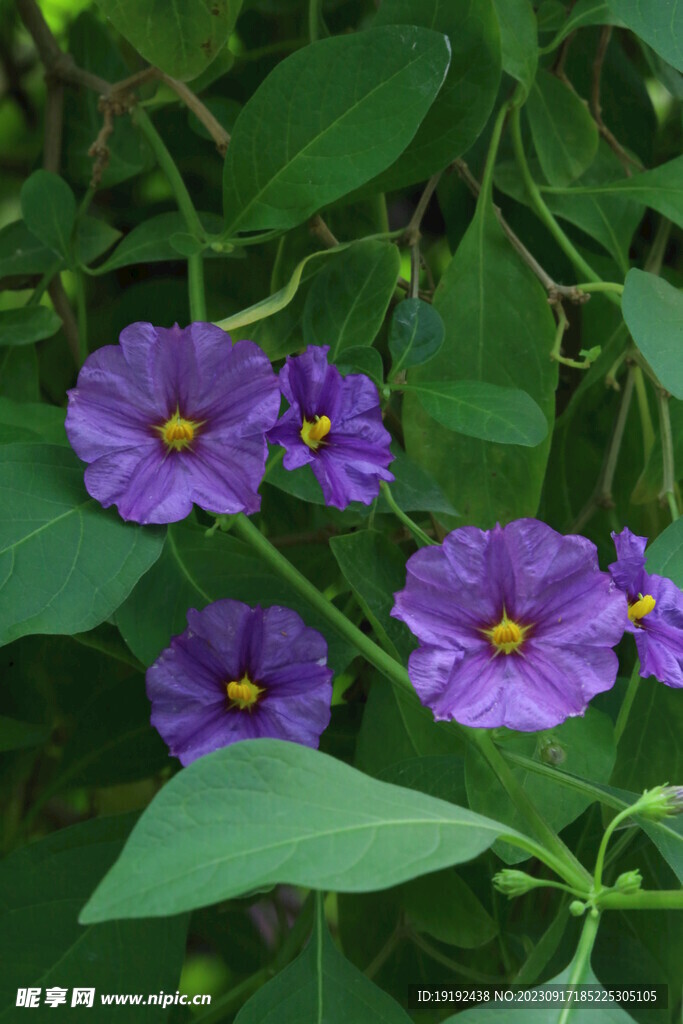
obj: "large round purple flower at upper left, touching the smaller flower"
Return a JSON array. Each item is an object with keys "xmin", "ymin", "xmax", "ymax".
[{"xmin": 67, "ymin": 324, "xmax": 280, "ymax": 523}]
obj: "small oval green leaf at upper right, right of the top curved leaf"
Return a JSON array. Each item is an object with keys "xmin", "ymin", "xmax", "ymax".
[{"xmin": 526, "ymin": 70, "xmax": 598, "ymax": 185}]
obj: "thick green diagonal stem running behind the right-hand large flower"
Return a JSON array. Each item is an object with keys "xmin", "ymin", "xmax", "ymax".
[{"xmin": 230, "ymin": 513, "xmax": 593, "ymax": 890}]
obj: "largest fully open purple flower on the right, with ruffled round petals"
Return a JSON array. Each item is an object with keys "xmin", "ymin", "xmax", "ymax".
[{"xmin": 391, "ymin": 519, "xmax": 626, "ymax": 732}]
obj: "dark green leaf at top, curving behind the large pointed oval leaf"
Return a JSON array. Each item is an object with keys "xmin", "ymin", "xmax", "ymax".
[{"xmin": 373, "ymin": 0, "xmax": 501, "ymax": 191}]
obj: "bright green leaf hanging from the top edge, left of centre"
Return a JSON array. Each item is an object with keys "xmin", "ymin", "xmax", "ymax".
[{"xmin": 97, "ymin": 0, "xmax": 237, "ymax": 81}]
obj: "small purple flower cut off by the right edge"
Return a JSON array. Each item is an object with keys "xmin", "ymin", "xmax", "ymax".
[{"xmin": 609, "ymin": 526, "xmax": 683, "ymax": 687}]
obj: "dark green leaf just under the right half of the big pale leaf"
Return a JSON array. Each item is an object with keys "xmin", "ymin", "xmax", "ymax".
[{"xmin": 399, "ymin": 868, "xmax": 498, "ymax": 949}]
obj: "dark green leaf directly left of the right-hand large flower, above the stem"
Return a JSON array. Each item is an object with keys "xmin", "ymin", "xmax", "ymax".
[{"xmin": 330, "ymin": 529, "xmax": 415, "ymax": 660}]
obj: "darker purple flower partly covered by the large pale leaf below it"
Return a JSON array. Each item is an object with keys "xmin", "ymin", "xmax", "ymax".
[{"xmin": 146, "ymin": 599, "xmax": 332, "ymax": 765}]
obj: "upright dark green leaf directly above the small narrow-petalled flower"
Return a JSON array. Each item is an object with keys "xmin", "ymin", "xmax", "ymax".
[{"xmin": 303, "ymin": 239, "xmax": 400, "ymax": 362}]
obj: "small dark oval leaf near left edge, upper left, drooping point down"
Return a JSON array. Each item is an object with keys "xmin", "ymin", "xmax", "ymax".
[{"xmin": 22, "ymin": 171, "xmax": 76, "ymax": 261}]
